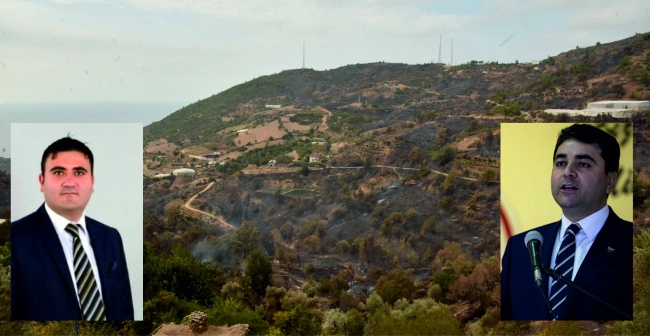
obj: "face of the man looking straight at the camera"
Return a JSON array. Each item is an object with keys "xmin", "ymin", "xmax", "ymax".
[{"xmin": 38, "ymin": 151, "xmax": 95, "ymax": 222}]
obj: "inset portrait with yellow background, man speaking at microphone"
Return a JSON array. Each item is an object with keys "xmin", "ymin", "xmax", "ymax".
[{"xmin": 501, "ymin": 123, "xmax": 633, "ymax": 320}]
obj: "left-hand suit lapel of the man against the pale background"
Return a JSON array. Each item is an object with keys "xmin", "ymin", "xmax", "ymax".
[{"xmin": 36, "ymin": 205, "xmax": 77, "ymax": 297}]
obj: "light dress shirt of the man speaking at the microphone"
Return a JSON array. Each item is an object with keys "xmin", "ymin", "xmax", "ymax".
[{"xmin": 548, "ymin": 204, "xmax": 609, "ymax": 295}]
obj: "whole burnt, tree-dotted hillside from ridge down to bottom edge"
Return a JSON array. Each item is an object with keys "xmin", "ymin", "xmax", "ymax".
[{"xmin": 138, "ymin": 33, "xmax": 650, "ymax": 334}]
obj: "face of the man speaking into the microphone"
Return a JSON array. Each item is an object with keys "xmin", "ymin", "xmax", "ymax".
[{"xmin": 551, "ymin": 139, "xmax": 617, "ymax": 222}]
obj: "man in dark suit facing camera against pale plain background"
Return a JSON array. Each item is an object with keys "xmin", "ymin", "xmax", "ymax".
[{"xmin": 11, "ymin": 137, "xmax": 133, "ymax": 321}]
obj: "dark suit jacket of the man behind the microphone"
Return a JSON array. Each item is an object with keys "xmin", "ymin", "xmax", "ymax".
[{"xmin": 501, "ymin": 208, "xmax": 633, "ymax": 320}]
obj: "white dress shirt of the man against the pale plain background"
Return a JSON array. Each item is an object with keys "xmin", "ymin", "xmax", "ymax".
[{"xmin": 45, "ymin": 203, "xmax": 104, "ymax": 307}]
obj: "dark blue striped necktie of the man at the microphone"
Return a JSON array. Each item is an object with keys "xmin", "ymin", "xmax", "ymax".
[{"xmin": 549, "ymin": 223, "xmax": 581, "ymax": 319}]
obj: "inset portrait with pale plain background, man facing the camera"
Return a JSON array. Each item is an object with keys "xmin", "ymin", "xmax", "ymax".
[{"xmin": 11, "ymin": 123, "xmax": 143, "ymax": 321}]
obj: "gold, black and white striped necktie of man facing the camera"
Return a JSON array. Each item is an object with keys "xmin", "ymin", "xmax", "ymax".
[{"xmin": 65, "ymin": 224, "xmax": 106, "ymax": 321}]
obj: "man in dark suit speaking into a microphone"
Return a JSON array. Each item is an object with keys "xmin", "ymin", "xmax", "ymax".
[{"xmin": 501, "ymin": 124, "xmax": 633, "ymax": 320}]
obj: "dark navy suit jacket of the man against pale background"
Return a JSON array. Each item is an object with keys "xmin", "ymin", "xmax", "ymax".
[{"xmin": 11, "ymin": 205, "xmax": 133, "ymax": 320}]
